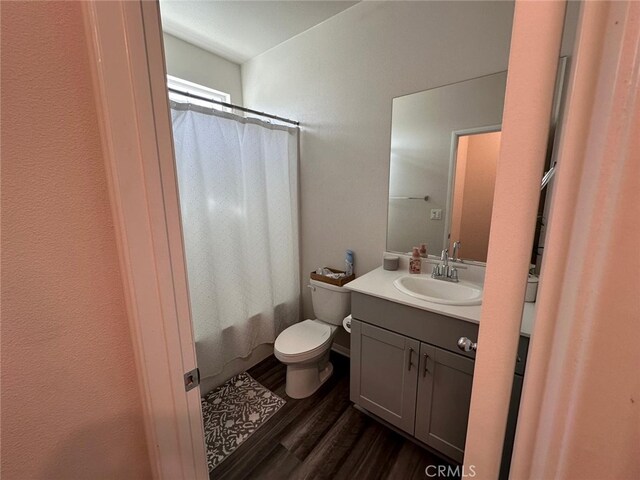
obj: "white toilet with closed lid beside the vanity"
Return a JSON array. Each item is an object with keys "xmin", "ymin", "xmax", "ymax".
[{"xmin": 273, "ymin": 280, "xmax": 351, "ymax": 398}]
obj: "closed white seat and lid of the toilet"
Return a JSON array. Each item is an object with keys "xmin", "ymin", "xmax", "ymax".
[{"xmin": 274, "ymin": 320, "xmax": 335, "ymax": 361}]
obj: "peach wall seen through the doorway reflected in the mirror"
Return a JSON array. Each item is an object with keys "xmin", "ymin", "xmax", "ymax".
[{"xmin": 452, "ymin": 132, "xmax": 501, "ymax": 262}]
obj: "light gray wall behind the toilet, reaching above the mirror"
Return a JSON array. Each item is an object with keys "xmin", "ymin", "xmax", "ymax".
[{"xmin": 242, "ymin": 2, "xmax": 513, "ymax": 334}]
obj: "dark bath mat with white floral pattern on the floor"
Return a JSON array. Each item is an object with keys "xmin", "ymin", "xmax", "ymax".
[{"xmin": 202, "ymin": 373, "xmax": 285, "ymax": 471}]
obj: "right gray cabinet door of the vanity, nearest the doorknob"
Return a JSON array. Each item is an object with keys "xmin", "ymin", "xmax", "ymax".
[{"xmin": 415, "ymin": 343, "xmax": 474, "ymax": 463}]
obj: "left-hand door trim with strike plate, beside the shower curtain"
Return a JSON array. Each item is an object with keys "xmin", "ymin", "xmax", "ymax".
[{"xmin": 83, "ymin": 0, "xmax": 208, "ymax": 480}]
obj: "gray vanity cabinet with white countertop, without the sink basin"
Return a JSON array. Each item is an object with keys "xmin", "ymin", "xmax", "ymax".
[{"xmin": 348, "ymin": 268, "xmax": 533, "ymax": 476}]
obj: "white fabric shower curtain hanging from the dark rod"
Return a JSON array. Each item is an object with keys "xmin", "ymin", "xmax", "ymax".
[{"xmin": 171, "ymin": 102, "xmax": 300, "ymax": 377}]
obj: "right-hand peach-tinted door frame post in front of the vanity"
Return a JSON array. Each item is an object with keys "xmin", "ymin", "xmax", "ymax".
[{"xmin": 464, "ymin": 0, "xmax": 566, "ymax": 479}]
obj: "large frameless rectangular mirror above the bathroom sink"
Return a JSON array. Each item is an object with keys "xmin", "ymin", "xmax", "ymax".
[{"xmin": 387, "ymin": 72, "xmax": 507, "ymax": 262}]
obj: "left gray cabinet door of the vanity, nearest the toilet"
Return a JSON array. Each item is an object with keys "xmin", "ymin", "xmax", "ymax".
[{"xmin": 350, "ymin": 319, "xmax": 420, "ymax": 435}]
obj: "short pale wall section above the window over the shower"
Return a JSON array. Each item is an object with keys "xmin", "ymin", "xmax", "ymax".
[{"xmin": 164, "ymin": 33, "xmax": 242, "ymax": 105}]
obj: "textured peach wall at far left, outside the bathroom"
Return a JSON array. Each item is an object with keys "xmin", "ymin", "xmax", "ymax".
[{"xmin": 1, "ymin": 2, "xmax": 150, "ymax": 480}]
